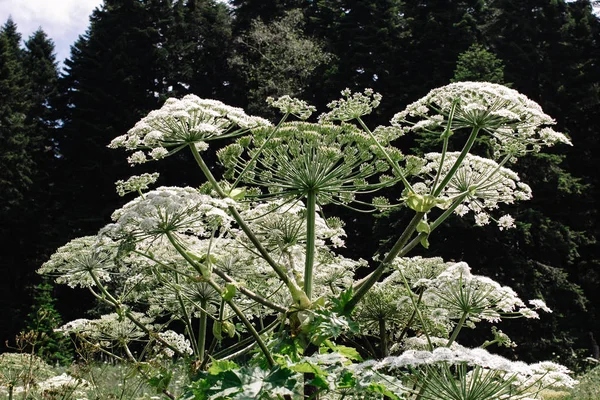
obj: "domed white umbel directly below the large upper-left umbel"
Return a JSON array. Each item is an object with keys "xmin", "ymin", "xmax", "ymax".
[{"xmin": 101, "ymin": 187, "xmax": 232, "ymax": 239}]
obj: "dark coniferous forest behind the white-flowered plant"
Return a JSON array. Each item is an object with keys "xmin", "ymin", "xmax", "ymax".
[{"xmin": 0, "ymin": 0, "xmax": 600, "ymax": 390}]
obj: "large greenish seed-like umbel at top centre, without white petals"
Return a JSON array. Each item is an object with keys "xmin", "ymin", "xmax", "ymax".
[{"xmin": 218, "ymin": 122, "xmax": 401, "ymax": 206}]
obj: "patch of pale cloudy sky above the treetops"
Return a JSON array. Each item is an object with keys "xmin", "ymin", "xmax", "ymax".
[{"xmin": 0, "ymin": 0, "xmax": 102, "ymax": 68}]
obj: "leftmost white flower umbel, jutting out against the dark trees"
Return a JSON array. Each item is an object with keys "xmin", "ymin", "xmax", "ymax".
[{"xmin": 37, "ymin": 236, "xmax": 118, "ymax": 288}]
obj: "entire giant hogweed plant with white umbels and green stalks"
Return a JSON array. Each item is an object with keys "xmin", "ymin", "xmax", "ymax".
[{"xmin": 40, "ymin": 82, "xmax": 575, "ymax": 400}]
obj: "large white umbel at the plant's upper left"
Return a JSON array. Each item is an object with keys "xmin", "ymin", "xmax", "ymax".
[{"xmin": 109, "ymin": 95, "xmax": 271, "ymax": 164}]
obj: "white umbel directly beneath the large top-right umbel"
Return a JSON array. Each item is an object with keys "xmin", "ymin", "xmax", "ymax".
[{"xmin": 421, "ymin": 152, "xmax": 531, "ymax": 230}]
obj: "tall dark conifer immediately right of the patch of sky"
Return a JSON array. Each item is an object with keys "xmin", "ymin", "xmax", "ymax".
[{"xmin": 59, "ymin": 0, "xmax": 169, "ymax": 239}]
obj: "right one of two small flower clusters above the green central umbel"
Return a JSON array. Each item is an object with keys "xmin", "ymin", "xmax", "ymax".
[{"xmin": 319, "ymin": 89, "xmax": 381, "ymax": 122}]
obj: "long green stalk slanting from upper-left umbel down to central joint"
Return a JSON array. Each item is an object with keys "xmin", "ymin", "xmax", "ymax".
[{"xmin": 190, "ymin": 144, "xmax": 310, "ymax": 308}]
